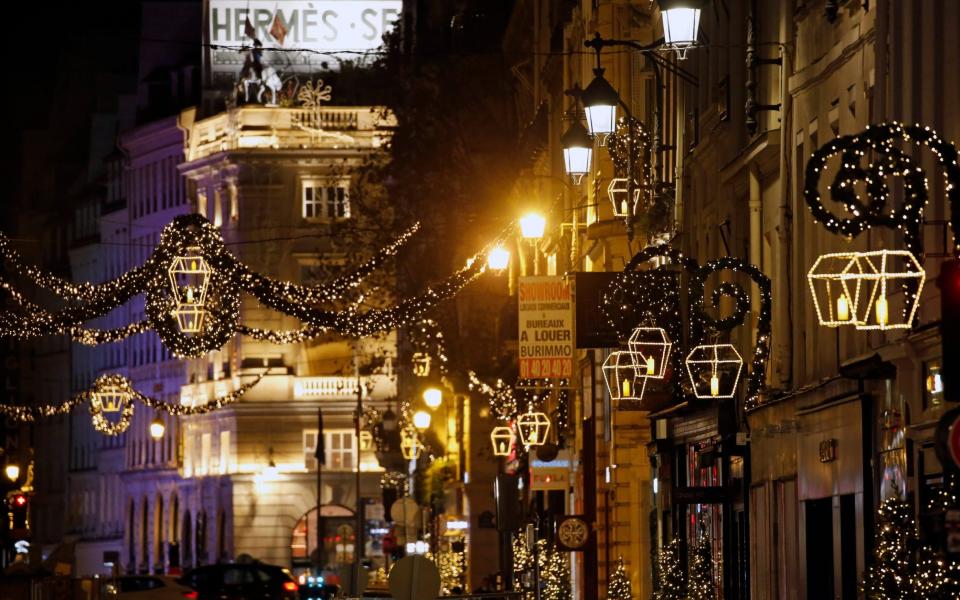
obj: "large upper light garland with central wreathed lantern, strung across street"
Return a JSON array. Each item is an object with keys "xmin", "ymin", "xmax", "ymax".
[{"xmin": 0, "ymin": 215, "xmax": 510, "ymax": 358}]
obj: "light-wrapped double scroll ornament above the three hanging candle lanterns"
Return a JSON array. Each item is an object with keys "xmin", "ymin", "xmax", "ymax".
[{"xmin": 601, "ymin": 244, "xmax": 773, "ymax": 410}]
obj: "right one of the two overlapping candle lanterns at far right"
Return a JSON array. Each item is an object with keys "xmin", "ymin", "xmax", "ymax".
[{"xmin": 852, "ymin": 250, "xmax": 927, "ymax": 331}]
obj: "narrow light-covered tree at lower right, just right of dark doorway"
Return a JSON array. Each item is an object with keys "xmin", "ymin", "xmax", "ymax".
[{"xmin": 861, "ymin": 498, "xmax": 917, "ymax": 600}]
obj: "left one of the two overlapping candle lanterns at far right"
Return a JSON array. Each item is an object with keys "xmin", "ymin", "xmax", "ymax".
[{"xmin": 807, "ymin": 252, "xmax": 875, "ymax": 327}]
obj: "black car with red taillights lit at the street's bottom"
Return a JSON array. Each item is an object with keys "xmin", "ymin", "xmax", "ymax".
[{"xmin": 180, "ymin": 562, "xmax": 300, "ymax": 600}]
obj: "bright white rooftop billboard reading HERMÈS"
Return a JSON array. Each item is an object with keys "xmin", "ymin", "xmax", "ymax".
[{"xmin": 204, "ymin": 0, "xmax": 403, "ymax": 87}]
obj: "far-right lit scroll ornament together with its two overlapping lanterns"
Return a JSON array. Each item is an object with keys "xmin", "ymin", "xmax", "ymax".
[{"xmin": 804, "ymin": 122, "xmax": 960, "ymax": 330}]
